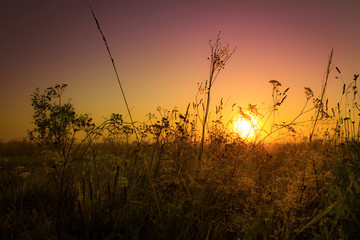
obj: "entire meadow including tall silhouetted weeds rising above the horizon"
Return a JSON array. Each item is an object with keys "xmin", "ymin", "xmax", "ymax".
[{"xmin": 0, "ymin": 23, "xmax": 360, "ymax": 239}]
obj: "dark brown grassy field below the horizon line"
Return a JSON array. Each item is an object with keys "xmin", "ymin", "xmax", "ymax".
[{"xmin": 0, "ymin": 132, "xmax": 360, "ymax": 239}]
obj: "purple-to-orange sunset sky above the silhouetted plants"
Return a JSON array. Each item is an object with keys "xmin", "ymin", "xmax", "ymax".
[{"xmin": 0, "ymin": 0, "xmax": 360, "ymax": 140}]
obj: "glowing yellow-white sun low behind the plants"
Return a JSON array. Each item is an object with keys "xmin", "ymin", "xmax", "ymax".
[{"xmin": 233, "ymin": 114, "xmax": 258, "ymax": 139}]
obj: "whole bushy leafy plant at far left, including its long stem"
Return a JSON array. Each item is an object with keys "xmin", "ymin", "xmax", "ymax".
[{"xmin": 29, "ymin": 84, "xmax": 95, "ymax": 237}]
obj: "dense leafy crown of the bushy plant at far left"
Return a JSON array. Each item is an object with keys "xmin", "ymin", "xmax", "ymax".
[{"xmin": 28, "ymin": 84, "xmax": 94, "ymax": 158}]
